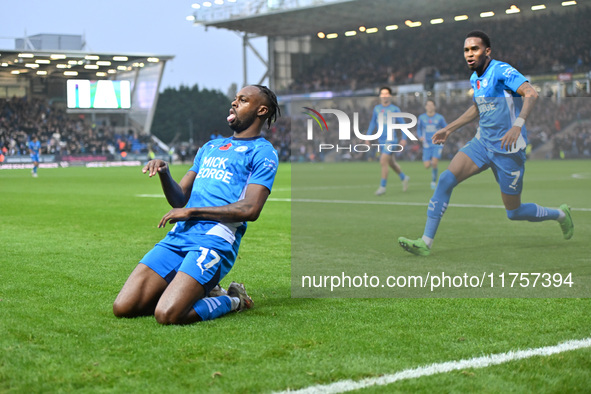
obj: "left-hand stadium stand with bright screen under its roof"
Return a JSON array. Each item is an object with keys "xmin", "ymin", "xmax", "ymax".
[{"xmin": 0, "ymin": 34, "xmax": 173, "ymax": 165}]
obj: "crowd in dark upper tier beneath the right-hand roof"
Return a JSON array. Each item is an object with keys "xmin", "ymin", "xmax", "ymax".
[{"xmin": 282, "ymin": 7, "xmax": 591, "ymax": 93}]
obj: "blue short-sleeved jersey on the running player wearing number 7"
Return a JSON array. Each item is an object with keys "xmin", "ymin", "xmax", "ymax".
[{"xmin": 470, "ymin": 60, "xmax": 527, "ymax": 153}]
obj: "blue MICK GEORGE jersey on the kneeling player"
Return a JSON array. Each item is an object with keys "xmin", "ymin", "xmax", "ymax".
[{"xmin": 162, "ymin": 137, "xmax": 278, "ymax": 250}]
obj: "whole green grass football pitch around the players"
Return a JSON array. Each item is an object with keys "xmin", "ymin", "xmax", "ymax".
[{"xmin": 0, "ymin": 161, "xmax": 591, "ymax": 393}]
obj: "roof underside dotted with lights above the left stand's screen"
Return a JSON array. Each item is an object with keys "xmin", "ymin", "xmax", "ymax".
[{"xmin": 0, "ymin": 49, "xmax": 173, "ymax": 79}]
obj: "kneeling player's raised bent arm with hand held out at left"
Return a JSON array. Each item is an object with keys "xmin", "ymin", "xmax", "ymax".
[{"xmin": 142, "ymin": 159, "xmax": 197, "ymax": 208}]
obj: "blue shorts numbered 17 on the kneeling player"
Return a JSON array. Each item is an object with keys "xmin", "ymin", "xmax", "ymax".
[{"xmin": 140, "ymin": 235, "xmax": 236, "ymax": 294}]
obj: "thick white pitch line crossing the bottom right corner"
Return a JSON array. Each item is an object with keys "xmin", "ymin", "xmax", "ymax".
[{"xmin": 277, "ymin": 338, "xmax": 591, "ymax": 394}]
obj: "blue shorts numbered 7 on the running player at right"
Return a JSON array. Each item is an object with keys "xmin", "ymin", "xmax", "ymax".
[{"xmin": 460, "ymin": 138, "xmax": 525, "ymax": 195}]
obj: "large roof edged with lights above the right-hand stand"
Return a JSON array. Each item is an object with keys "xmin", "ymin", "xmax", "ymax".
[{"xmin": 193, "ymin": 0, "xmax": 581, "ymax": 36}]
